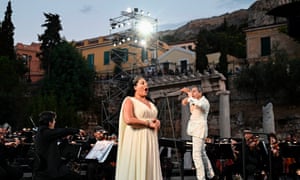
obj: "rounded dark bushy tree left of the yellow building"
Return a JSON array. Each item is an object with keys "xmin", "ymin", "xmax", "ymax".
[{"xmin": 43, "ymin": 41, "xmax": 94, "ymax": 110}]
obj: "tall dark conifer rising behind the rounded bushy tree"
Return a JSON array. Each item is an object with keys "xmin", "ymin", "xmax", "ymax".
[{"xmin": 38, "ymin": 13, "xmax": 62, "ymax": 74}]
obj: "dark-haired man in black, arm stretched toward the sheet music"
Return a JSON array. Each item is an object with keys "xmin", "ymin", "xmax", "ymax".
[{"xmin": 35, "ymin": 111, "xmax": 85, "ymax": 180}]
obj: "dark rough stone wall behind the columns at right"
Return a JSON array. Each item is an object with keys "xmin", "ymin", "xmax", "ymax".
[{"xmin": 207, "ymin": 76, "xmax": 300, "ymax": 140}]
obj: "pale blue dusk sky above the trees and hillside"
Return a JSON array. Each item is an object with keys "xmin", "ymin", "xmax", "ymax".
[{"xmin": 0, "ymin": 0, "xmax": 256, "ymax": 44}]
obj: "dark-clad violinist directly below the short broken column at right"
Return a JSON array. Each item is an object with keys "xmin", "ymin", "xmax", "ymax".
[{"xmin": 268, "ymin": 133, "xmax": 283, "ymax": 180}]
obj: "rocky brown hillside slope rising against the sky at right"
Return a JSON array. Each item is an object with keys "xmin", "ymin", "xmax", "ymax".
[{"xmin": 159, "ymin": 0, "xmax": 286, "ymax": 43}]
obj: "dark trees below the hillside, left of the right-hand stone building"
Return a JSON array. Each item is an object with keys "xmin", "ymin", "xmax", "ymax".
[{"xmin": 196, "ymin": 19, "xmax": 246, "ymax": 77}]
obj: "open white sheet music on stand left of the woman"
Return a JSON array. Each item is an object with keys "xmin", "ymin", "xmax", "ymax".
[{"xmin": 85, "ymin": 140, "xmax": 114, "ymax": 163}]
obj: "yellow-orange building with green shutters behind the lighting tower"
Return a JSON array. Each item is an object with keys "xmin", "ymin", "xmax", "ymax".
[{"xmin": 76, "ymin": 36, "xmax": 168, "ymax": 77}]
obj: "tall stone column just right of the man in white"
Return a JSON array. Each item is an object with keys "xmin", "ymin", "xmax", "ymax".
[{"xmin": 217, "ymin": 91, "xmax": 231, "ymax": 138}]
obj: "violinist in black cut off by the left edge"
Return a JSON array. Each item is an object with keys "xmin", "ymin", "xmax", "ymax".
[{"xmin": 0, "ymin": 127, "xmax": 23, "ymax": 180}]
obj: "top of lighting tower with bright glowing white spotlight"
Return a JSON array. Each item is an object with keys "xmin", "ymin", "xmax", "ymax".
[{"xmin": 109, "ymin": 8, "xmax": 158, "ymax": 47}]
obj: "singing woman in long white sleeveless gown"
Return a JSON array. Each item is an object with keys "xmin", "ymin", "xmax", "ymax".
[{"xmin": 116, "ymin": 76, "xmax": 162, "ymax": 180}]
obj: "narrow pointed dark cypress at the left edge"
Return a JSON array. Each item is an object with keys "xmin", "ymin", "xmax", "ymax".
[{"xmin": 0, "ymin": 1, "xmax": 16, "ymax": 60}]
